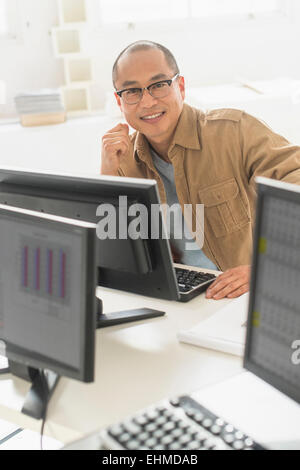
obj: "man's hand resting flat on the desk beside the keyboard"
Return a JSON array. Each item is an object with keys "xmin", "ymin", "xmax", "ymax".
[{"xmin": 206, "ymin": 265, "xmax": 250, "ymax": 300}]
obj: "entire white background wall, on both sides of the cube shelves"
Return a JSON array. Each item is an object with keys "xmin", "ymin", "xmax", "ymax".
[{"xmin": 0, "ymin": 0, "xmax": 300, "ymax": 114}]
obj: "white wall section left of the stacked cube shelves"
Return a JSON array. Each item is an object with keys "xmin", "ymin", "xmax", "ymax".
[{"xmin": 0, "ymin": 0, "xmax": 64, "ymax": 114}]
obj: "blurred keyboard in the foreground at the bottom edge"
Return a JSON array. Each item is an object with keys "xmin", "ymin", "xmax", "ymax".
[{"xmin": 99, "ymin": 395, "xmax": 264, "ymax": 450}]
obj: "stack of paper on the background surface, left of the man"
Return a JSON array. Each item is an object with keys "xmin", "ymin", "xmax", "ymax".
[{"xmin": 15, "ymin": 89, "xmax": 65, "ymax": 125}]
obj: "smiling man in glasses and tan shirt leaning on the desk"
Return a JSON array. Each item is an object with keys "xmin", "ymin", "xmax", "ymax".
[{"xmin": 101, "ymin": 41, "xmax": 300, "ymax": 299}]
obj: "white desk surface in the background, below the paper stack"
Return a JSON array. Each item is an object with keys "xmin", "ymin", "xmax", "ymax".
[{"xmin": 0, "ymin": 114, "xmax": 119, "ymax": 175}]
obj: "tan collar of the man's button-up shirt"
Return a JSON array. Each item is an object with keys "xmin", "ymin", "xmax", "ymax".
[{"xmin": 134, "ymin": 103, "xmax": 201, "ymax": 167}]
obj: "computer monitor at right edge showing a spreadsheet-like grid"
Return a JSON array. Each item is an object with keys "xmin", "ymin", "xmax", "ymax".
[{"xmin": 244, "ymin": 178, "xmax": 300, "ymax": 403}]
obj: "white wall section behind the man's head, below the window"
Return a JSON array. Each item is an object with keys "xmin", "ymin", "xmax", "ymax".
[{"xmin": 86, "ymin": 0, "xmax": 300, "ymax": 110}]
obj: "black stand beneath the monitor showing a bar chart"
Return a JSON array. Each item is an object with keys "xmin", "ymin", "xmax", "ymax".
[{"xmin": 9, "ymin": 360, "xmax": 59, "ymax": 419}]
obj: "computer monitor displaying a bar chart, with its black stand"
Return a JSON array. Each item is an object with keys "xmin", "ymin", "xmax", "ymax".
[{"xmin": 0, "ymin": 205, "xmax": 96, "ymax": 418}]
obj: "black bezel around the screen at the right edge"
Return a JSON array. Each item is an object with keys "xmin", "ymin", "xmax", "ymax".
[{"xmin": 243, "ymin": 178, "xmax": 300, "ymax": 403}]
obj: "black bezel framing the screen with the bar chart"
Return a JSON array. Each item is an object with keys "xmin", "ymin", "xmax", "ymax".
[{"xmin": 0, "ymin": 206, "xmax": 97, "ymax": 383}]
